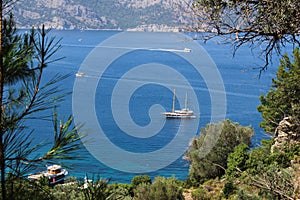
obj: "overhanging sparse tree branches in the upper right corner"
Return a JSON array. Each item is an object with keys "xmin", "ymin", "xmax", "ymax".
[{"xmin": 188, "ymin": 0, "xmax": 300, "ymax": 70}]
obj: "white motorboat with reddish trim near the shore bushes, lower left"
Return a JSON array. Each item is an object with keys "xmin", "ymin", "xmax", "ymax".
[{"xmin": 28, "ymin": 165, "xmax": 68, "ymax": 186}]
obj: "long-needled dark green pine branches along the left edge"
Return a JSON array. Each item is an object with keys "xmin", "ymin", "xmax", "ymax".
[{"xmin": 0, "ymin": 13, "xmax": 82, "ymax": 200}]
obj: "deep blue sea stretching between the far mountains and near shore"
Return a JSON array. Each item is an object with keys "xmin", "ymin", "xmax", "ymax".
[{"xmin": 25, "ymin": 30, "xmax": 279, "ymax": 183}]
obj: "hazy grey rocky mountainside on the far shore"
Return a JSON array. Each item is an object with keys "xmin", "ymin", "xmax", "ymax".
[{"xmin": 14, "ymin": 0, "xmax": 190, "ymax": 31}]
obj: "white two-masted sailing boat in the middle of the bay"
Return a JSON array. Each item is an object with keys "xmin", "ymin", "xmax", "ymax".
[{"xmin": 162, "ymin": 89, "xmax": 196, "ymax": 119}]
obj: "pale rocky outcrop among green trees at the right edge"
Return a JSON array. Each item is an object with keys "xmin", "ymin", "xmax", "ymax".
[{"xmin": 272, "ymin": 117, "xmax": 300, "ymax": 151}]
